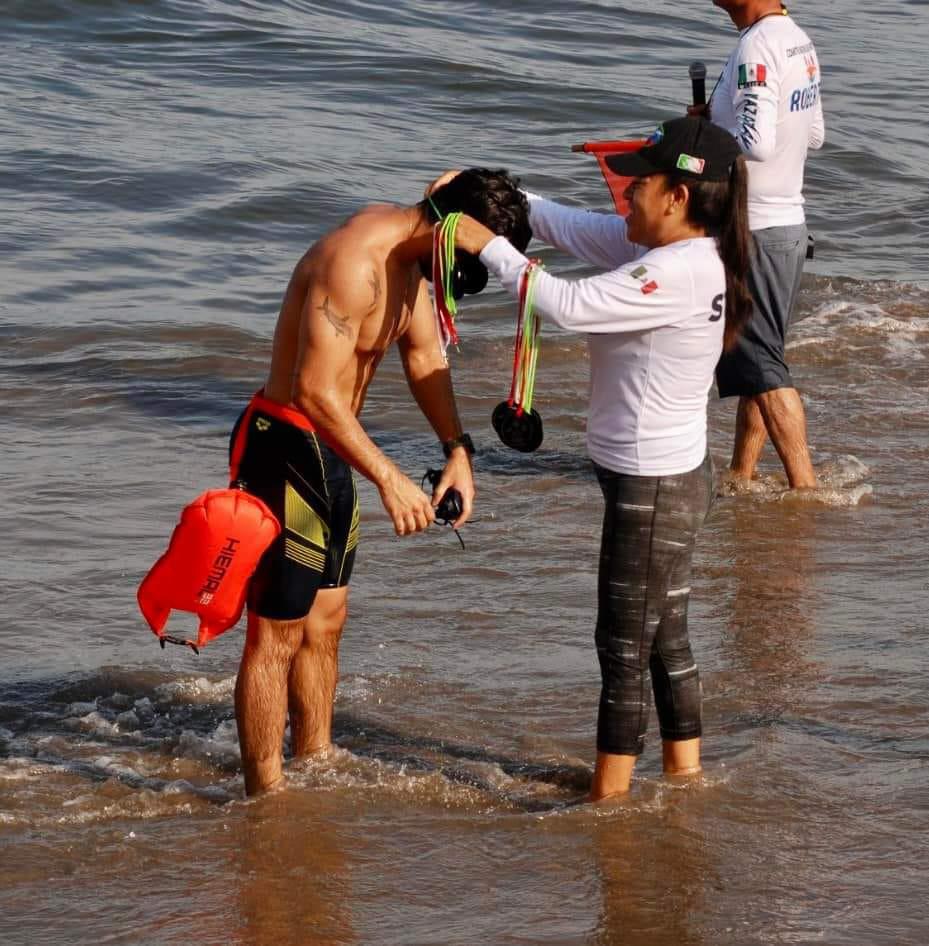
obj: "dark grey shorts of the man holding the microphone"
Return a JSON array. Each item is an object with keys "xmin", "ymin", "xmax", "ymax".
[{"xmin": 716, "ymin": 224, "xmax": 807, "ymax": 397}]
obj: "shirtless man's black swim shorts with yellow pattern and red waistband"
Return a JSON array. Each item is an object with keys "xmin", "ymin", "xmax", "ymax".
[{"xmin": 229, "ymin": 391, "xmax": 359, "ymax": 621}]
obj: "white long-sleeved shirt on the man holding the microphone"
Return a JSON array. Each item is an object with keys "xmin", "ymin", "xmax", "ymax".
[{"xmin": 710, "ymin": 14, "xmax": 825, "ymax": 230}]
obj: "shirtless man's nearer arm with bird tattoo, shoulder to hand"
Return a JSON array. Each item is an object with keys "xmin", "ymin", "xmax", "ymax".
[{"xmin": 294, "ymin": 260, "xmax": 435, "ymax": 535}]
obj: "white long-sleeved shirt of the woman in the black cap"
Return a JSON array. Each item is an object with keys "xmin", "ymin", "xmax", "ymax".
[{"xmin": 481, "ymin": 194, "xmax": 726, "ymax": 476}]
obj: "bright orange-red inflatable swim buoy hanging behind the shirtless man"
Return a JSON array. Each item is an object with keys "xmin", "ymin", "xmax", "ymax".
[{"xmin": 137, "ymin": 489, "xmax": 281, "ymax": 650}]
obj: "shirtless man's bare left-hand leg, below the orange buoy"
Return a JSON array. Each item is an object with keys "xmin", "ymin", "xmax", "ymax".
[{"xmin": 235, "ymin": 611, "xmax": 303, "ymax": 795}]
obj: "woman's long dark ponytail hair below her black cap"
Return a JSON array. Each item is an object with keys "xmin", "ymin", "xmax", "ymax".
[{"xmin": 668, "ymin": 155, "xmax": 752, "ymax": 351}]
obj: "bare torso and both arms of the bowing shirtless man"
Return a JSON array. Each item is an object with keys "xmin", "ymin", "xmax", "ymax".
[{"xmin": 265, "ymin": 205, "xmax": 474, "ymax": 535}]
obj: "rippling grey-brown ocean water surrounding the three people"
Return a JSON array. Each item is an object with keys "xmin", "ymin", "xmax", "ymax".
[{"xmin": 0, "ymin": 0, "xmax": 929, "ymax": 946}]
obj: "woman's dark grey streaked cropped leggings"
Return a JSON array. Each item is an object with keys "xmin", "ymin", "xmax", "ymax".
[{"xmin": 595, "ymin": 456, "xmax": 715, "ymax": 755}]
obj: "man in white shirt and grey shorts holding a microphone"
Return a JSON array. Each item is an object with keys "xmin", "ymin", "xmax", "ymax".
[{"xmin": 688, "ymin": 0, "xmax": 825, "ymax": 489}]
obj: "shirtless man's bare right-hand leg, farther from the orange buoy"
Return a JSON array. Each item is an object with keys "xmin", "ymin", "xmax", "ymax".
[{"xmin": 287, "ymin": 587, "xmax": 348, "ymax": 758}]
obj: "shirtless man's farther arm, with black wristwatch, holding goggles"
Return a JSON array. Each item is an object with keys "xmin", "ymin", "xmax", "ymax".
[{"xmin": 397, "ymin": 281, "xmax": 474, "ymax": 528}]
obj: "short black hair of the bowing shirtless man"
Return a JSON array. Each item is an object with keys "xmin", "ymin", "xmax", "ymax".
[{"xmin": 419, "ymin": 168, "xmax": 532, "ymax": 252}]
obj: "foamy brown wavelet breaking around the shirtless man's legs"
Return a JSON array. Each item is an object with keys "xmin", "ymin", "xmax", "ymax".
[{"xmin": 0, "ymin": 673, "xmax": 590, "ymax": 826}]
